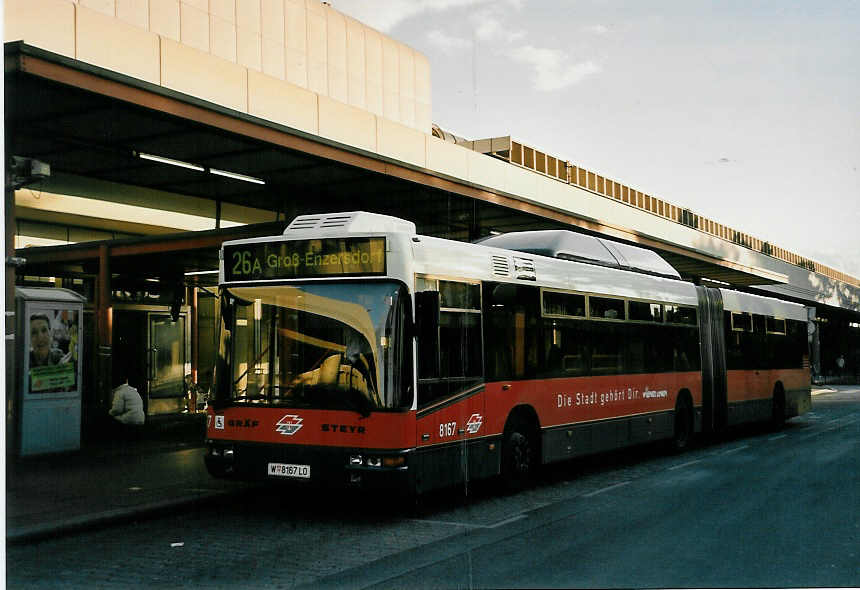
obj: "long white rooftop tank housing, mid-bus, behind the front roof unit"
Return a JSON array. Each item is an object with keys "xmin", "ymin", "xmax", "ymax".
[{"xmin": 479, "ymin": 229, "xmax": 681, "ymax": 279}]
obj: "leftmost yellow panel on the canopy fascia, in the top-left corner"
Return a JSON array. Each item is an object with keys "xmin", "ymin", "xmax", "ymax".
[{"xmin": 3, "ymin": 0, "xmax": 75, "ymax": 57}]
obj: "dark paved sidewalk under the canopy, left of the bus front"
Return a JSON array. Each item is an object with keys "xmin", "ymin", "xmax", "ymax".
[{"xmin": 6, "ymin": 416, "xmax": 248, "ymax": 542}]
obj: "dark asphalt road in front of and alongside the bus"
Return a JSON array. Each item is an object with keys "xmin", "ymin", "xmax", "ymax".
[{"xmin": 6, "ymin": 388, "xmax": 860, "ymax": 588}]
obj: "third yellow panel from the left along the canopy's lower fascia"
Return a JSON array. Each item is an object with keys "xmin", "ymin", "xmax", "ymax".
[{"xmin": 161, "ymin": 38, "xmax": 248, "ymax": 112}]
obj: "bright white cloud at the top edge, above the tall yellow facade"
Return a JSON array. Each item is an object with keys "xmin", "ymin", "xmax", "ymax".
[{"xmin": 331, "ymin": 0, "xmax": 522, "ymax": 33}]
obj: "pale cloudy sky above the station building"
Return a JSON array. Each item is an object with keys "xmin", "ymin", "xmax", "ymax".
[{"xmin": 330, "ymin": 0, "xmax": 860, "ymax": 277}]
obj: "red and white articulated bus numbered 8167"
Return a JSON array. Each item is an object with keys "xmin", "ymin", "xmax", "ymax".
[{"xmin": 206, "ymin": 212, "xmax": 811, "ymax": 493}]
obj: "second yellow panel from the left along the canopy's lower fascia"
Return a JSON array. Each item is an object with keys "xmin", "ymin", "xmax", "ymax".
[{"xmin": 73, "ymin": 6, "xmax": 160, "ymax": 84}]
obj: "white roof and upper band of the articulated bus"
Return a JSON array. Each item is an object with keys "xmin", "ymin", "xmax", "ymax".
[{"xmin": 224, "ymin": 211, "xmax": 807, "ymax": 320}]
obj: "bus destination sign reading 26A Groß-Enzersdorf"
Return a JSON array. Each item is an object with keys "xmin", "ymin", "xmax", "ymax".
[{"xmin": 224, "ymin": 238, "xmax": 385, "ymax": 281}]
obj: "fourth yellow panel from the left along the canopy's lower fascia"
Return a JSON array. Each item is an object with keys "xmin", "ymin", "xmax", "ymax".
[{"xmin": 248, "ymin": 70, "xmax": 319, "ymax": 134}]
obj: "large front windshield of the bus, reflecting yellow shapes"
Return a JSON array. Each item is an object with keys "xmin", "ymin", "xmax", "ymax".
[{"xmin": 216, "ymin": 281, "xmax": 413, "ymax": 416}]
